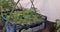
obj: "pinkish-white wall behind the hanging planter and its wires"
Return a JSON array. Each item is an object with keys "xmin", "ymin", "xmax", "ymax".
[{"xmin": 15, "ymin": 0, "xmax": 60, "ymax": 22}]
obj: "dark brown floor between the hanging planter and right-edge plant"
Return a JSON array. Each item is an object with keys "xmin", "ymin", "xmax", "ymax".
[{"xmin": 36, "ymin": 21, "xmax": 56, "ymax": 32}]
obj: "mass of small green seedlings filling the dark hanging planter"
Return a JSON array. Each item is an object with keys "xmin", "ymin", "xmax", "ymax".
[{"xmin": 6, "ymin": 9, "xmax": 44, "ymax": 25}]
